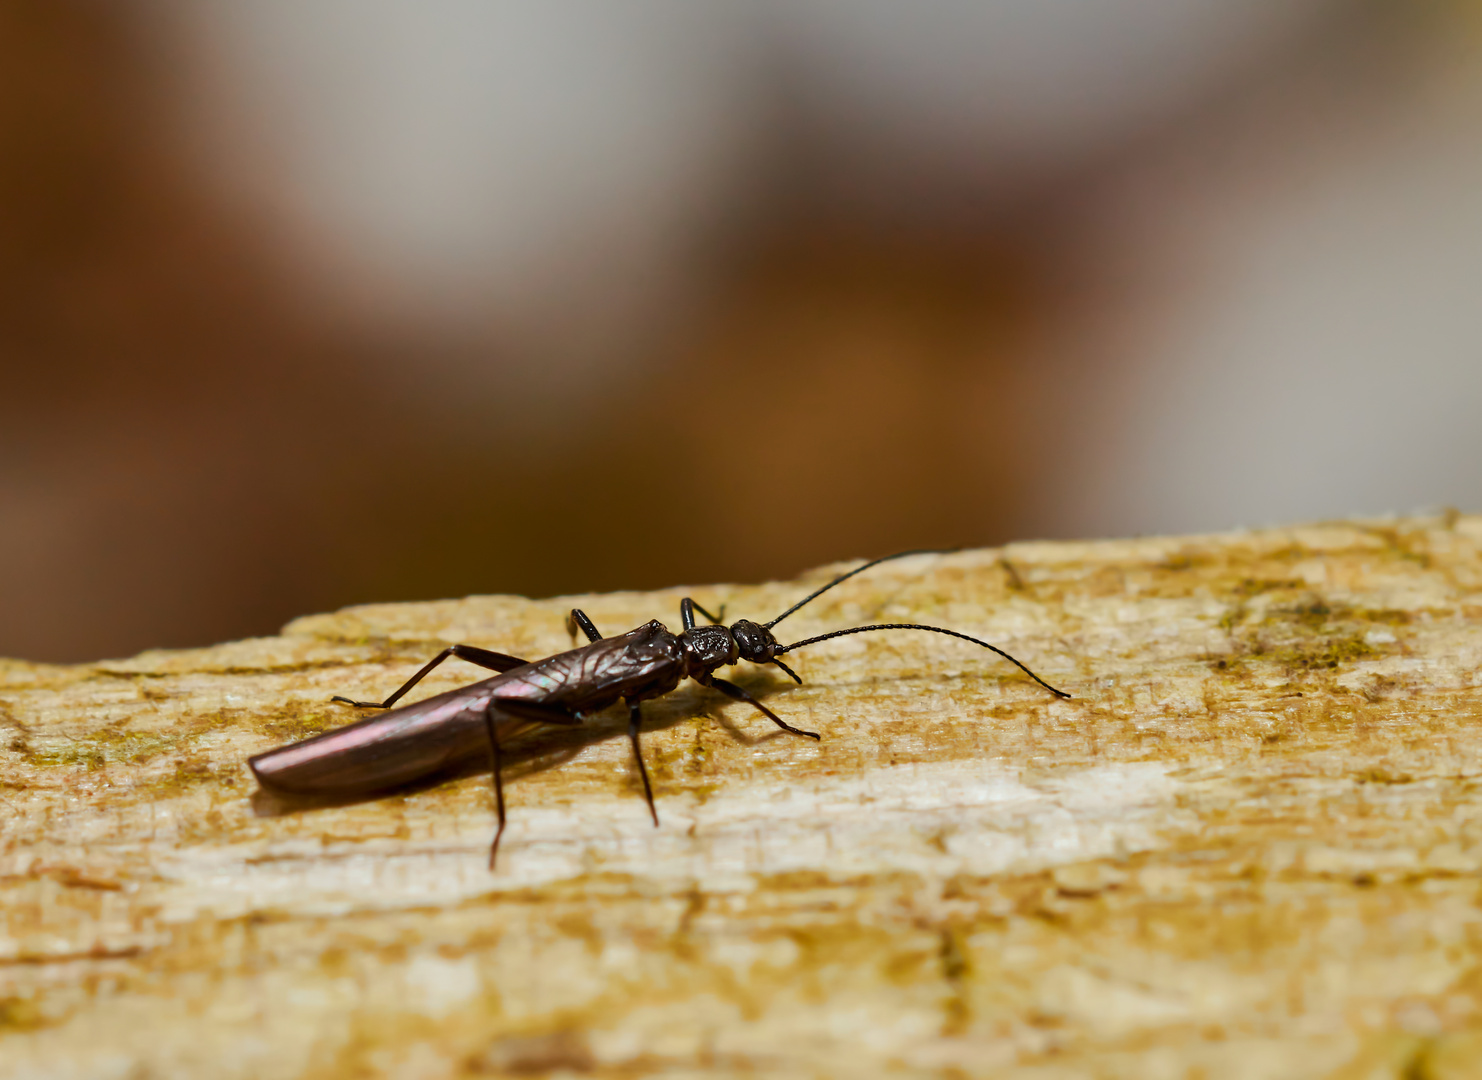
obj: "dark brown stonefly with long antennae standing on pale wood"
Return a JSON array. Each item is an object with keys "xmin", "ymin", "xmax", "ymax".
[{"xmin": 247, "ymin": 551, "xmax": 1070, "ymax": 870}]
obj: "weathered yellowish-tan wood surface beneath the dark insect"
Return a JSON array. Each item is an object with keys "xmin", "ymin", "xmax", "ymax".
[{"xmin": 0, "ymin": 516, "xmax": 1482, "ymax": 1080}]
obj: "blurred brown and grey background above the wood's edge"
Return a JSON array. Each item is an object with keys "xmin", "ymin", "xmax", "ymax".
[{"xmin": 0, "ymin": 0, "xmax": 1482, "ymax": 661}]
